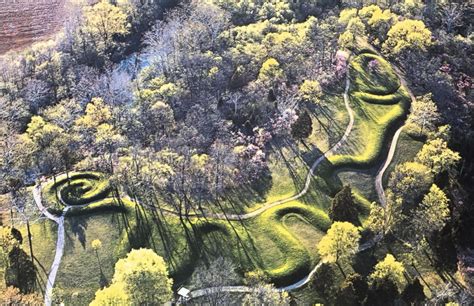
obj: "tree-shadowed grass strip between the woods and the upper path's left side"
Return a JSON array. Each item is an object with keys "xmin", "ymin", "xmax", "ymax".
[{"xmin": 211, "ymin": 93, "xmax": 349, "ymax": 214}]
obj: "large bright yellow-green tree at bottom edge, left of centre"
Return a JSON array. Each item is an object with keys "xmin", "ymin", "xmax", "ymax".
[{"xmin": 91, "ymin": 249, "xmax": 173, "ymax": 305}]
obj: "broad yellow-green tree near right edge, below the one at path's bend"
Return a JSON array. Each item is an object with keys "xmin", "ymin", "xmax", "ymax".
[{"xmin": 415, "ymin": 138, "xmax": 461, "ymax": 175}]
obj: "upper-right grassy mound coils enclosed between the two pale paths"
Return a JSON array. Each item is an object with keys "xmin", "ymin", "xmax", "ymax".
[{"xmin": 329, "ymin": 53, "xmax": 410, "ymax": 169}]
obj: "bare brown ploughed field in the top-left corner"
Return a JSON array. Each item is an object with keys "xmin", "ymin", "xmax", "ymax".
[{"xmin": 0, "ymin": 0, "xmax": 66, "ymax": 54}]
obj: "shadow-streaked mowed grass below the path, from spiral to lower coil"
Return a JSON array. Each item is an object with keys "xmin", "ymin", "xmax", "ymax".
[{"xmin": 27, "ymin": 184, "xmax": 330, "ymax": 305}]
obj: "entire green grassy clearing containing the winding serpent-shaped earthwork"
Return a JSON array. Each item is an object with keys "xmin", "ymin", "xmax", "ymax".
[{"xmin": 12, "ymin": 50, "xmax": 422, "ymax": 305}]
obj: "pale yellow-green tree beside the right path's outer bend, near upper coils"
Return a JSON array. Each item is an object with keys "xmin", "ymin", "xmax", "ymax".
[{"xmin": 407, "ymin": 94, "xmax": 440, "ymax": 135}]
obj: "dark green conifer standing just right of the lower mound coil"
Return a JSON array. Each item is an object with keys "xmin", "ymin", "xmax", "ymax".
[{"xmin": 328, "ymin": 185, "xmax": 360, "ymax": 225}]
